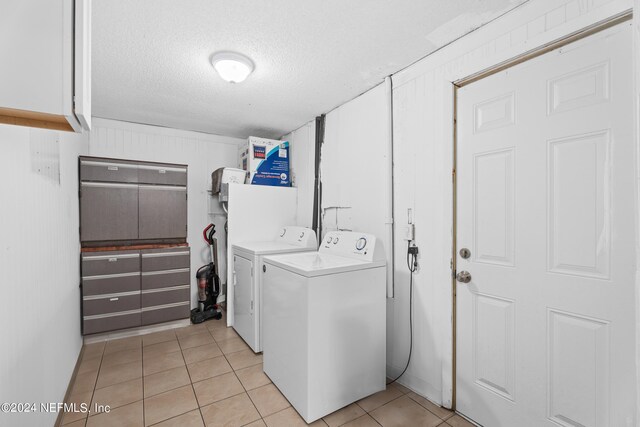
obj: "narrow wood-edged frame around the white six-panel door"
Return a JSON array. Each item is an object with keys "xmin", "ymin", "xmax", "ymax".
[{"xmin": 451, "ymin": 9, "xmax": 640, "ymax": 411}]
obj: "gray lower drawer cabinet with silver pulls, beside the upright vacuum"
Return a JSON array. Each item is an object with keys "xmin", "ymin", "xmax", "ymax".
[{"xmin": 81, "ymin": 247, "xmax": 191, "ymax": 335}]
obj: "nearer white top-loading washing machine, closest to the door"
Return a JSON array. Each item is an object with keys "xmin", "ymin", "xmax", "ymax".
[{"xmin": 262, "ymin": 232, "xmax": 387, "ymax": 423}]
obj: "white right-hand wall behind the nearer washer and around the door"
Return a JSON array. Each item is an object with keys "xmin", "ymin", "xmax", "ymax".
[{"xmin": 312, "ymin": 0, "xmax": 640, "ymax": 407}]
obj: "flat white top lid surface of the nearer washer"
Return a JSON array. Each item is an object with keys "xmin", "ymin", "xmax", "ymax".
[{"xmin": 263, "ymin": 252, "xmax": 386, "ymax": 277}]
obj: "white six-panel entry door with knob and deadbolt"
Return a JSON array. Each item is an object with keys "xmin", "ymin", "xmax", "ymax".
[{"xmin": 456, "ymin": 23, "xmax": 636, "ymax": 427}]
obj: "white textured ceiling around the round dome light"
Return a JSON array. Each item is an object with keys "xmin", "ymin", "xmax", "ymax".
[{"xmin": 92, "ymin": 0, "xmax": 525, "ymax": 138}]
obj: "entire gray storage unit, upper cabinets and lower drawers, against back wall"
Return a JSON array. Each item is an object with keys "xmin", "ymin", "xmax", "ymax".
[{"xmin": 79, "ymin": 156, "xmax": 191, "ymax": 335}]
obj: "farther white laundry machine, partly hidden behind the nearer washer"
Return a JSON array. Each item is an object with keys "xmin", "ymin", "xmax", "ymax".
[{"xmin": 232, "ymin": 226, "xmax": 318, "ymax": 353}]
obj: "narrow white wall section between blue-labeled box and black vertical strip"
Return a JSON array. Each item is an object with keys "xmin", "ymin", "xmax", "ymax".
[{"xmin": 281, "ymin": 121, "xmax": 316, "ymax": 228}]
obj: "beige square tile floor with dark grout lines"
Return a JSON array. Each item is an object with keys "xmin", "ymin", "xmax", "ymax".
[{"xmin": 62, "ymin": 312, "xmax": 471, "ymax": 427}]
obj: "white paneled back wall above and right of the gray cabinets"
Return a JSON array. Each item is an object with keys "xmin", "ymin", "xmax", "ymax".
[{"xmin": 88, "ymin": 118, "xmax": 244, "ymax": 307}]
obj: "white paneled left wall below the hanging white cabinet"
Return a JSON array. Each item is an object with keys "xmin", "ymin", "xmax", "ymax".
[{"xmin": 0, "ymin": 125, "xmax": 87, "ymax": 426}]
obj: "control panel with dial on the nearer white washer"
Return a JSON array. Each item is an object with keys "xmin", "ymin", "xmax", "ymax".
[{"xmin": 318, "ymin": 231, "xmax": 385, "ymax": 261}]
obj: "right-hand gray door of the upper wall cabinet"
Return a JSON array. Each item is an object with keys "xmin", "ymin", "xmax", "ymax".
[{"xmin": 138, "ymin": 185, "xmax": 187, "ymax": 239}]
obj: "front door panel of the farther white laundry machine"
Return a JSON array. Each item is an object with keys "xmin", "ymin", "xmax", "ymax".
[{"xmin": 233, "ymin": 255, "xmax": 256, "ymax": 346}]
